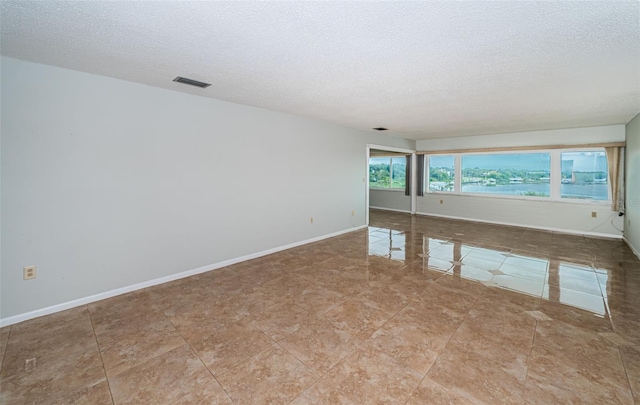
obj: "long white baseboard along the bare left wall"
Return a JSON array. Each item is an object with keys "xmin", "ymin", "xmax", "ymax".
[{"xmin": 0, "ymin": 225, "xmax": 367, "ymax": 327}]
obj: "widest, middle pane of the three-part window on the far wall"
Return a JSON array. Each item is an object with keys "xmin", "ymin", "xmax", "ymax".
[{"xmin": 462, "ymin": 153, "xmax": 551, "ymax": 197}]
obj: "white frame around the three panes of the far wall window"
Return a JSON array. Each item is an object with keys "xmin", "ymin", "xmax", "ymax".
[{"xmin": 424, "ymin": 147, "xmax": 611, "ymax": 206}]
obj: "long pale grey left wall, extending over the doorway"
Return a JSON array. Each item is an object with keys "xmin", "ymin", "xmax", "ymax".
[{"xmin": 0, "ymin": 58, "xmax": 415, "ymax": 323}]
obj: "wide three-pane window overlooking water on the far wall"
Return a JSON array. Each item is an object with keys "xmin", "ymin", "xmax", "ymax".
[{"xmin": 424, "ymin": 148, "xmax": 610, "ymax": 202}]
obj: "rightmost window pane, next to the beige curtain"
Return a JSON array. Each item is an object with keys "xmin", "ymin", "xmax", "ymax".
[{"xmin": 560, "ymin": 151, "xmax": 609, "ymax": 200}]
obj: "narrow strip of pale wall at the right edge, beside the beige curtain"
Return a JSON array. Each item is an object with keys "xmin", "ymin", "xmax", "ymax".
[{"xmin": 624, "ymin": 114, "xmax": 640, "ymax": 255}]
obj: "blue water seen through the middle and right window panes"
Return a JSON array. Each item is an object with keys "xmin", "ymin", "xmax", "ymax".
[{"xmin": 462, "ymin": 183, "xmax": 609, "ymax": 201}]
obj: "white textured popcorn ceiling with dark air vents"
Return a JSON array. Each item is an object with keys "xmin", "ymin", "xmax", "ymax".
[{"xmin": 0, "ymin": 1, "xmax": 640, "ymax": 139}]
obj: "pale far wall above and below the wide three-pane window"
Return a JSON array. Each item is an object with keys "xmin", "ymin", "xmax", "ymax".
[{"xmin": 416, "ymin": 125, "xmax": 625, "ymax": 237}]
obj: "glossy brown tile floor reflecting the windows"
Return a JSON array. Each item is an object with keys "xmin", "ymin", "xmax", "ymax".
[{"xmin": 0, "ymin": 211, "xmax": 640, "ymax": 405}]
